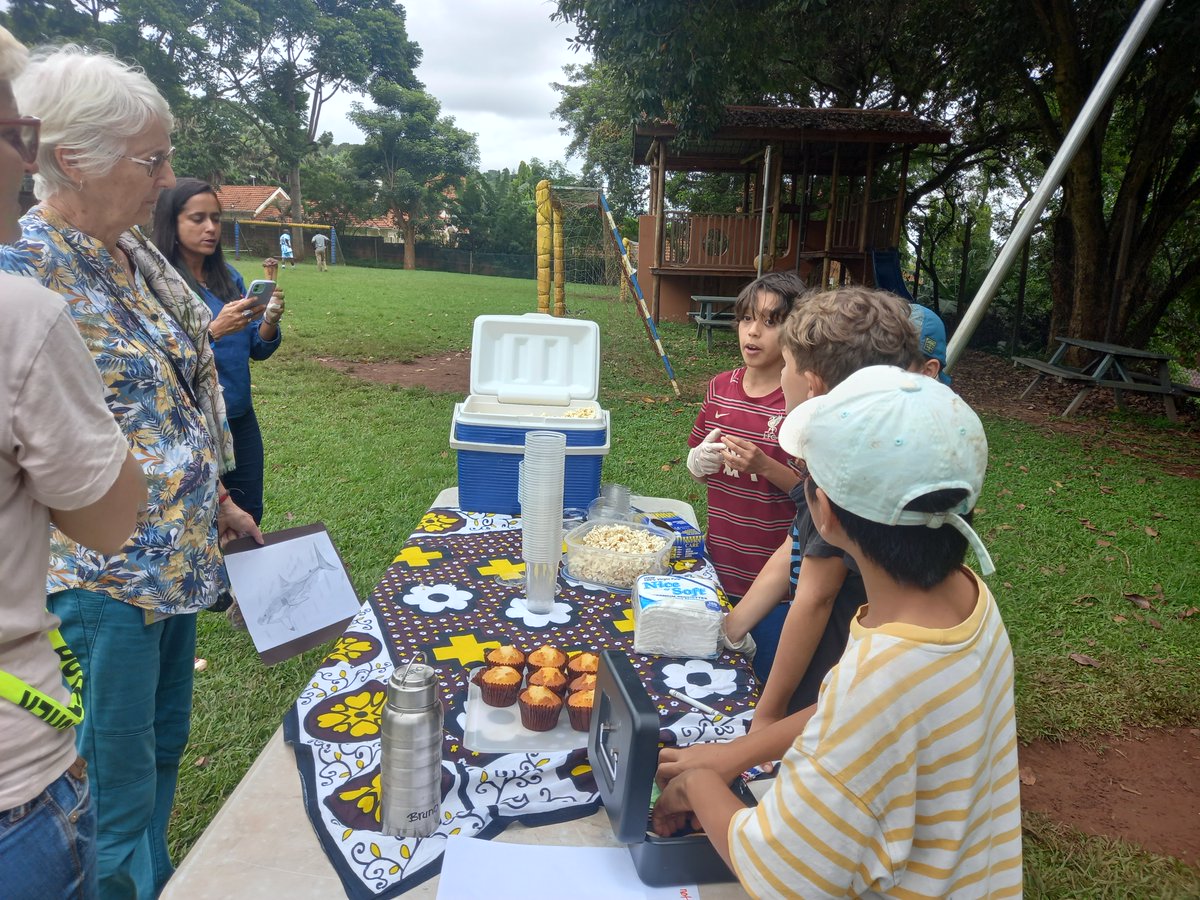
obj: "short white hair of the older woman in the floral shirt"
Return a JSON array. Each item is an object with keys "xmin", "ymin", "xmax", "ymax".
[{"xmin": 13, "ymin": 44, "xmax": 175, "ymax": 200}]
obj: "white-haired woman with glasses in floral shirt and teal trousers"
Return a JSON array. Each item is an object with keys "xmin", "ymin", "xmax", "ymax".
[{"xmin": 0, "ymin": 47, "xmax": 262, "ymax": 898}]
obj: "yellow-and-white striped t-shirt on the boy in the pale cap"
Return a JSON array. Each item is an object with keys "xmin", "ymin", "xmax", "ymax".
[{"xmin": 728, "ymin": 570, "xmax": 1021, "ymax": 900}]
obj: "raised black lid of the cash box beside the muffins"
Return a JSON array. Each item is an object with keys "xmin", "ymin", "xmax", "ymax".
[{"xmin": 588, "ymin": 650, "xmax": 660, "ymax": 844}]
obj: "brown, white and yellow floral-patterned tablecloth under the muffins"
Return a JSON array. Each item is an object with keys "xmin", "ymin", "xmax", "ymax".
[{"xmin": 283, "ymin": 509, "xmax": 755, "ymax": 899}]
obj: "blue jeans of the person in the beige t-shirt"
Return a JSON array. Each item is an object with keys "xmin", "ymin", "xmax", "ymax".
[{"xmin": 0, "ymin": 772, "xmax": 96, "ymax": 900}]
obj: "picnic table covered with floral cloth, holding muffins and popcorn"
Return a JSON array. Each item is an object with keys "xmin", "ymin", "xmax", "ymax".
[{"xmin": 164, "ymin": 488, "xmax": 757, "ymax": 900}]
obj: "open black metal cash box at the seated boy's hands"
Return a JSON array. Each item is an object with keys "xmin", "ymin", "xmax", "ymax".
[{"xmin": 588, "ymin": 650, "xmax": 756, "ymax": 887}]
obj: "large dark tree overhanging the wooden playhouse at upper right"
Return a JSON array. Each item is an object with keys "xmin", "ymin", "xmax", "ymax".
[{"xmin": 556, "ymin": 0, "xmax": 1200, "ymax": 346}]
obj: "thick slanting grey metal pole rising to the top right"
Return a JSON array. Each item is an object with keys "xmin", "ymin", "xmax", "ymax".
[{"xmin": 946, "ymin": 0, "xmax": 1166, "ymax": 371}]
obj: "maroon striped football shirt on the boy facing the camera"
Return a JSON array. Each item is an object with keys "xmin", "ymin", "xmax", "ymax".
[{"xmin": 688, "ymin": 366, "xmax": 796, "ymax": 598}]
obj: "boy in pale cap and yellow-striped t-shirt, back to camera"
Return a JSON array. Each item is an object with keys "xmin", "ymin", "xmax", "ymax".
[{"xmin": 654, "ymin": 366, "xmax": 1021, "ymax": 898}]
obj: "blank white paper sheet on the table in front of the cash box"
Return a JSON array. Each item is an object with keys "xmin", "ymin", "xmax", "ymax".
[{"xmin": 438, "ymin": 838, "xmax": 700, "ymax": 900}]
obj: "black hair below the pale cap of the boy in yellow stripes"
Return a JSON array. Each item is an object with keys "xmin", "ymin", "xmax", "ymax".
[{"xmin": 804, "ymin": 478, "xmax": 974, "ymax": 590}]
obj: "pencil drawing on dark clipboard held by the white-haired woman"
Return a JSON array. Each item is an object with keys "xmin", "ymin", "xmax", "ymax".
[{"xmin": 224, "ymin": 523, "xmax": 359, "ymax": 665}]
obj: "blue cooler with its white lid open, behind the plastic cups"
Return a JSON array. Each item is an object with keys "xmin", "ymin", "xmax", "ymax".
[{"xmin": 450, "ymin": 313, "xmax": 610, "ymax": 515}]
